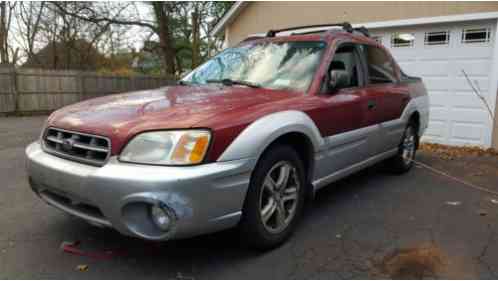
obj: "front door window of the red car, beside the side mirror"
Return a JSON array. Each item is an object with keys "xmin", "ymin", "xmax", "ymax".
[{"xmin": 328, "ymin": 44, "xmax": 361, "ymax": 88}]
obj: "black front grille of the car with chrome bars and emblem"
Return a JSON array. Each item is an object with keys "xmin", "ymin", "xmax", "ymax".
[{"xmin": 43, "ymin": 127, "xmax": 111, "ymax": 166}]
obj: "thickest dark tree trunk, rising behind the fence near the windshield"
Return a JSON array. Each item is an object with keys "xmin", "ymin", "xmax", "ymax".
[{"xmin": 152, "ymin": 2, "xmax": 176, "ymax": 76}]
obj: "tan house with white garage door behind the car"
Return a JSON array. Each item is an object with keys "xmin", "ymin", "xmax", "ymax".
[{"xmin": 213, "ymin": 2, "xmax": 498, "ymax": 148}]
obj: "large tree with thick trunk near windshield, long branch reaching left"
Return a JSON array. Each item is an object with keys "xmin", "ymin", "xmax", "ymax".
[{"xmin": 51, "ymin": 1, "xmax": 233, "ymax": 75}]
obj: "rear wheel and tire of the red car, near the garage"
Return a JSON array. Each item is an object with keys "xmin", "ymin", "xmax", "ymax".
[{"xmin": 388, "ymin": 122, "xmax": 419, "ymax": 174}]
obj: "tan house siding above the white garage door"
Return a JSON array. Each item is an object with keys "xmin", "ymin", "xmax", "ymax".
[{"xmin": 225, "ymin": 1, "xmax": 498, "ymax": 46}]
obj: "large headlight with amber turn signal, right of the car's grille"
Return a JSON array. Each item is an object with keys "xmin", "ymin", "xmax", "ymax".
[{"xmin": 119, "ymin": 130, "xmax": 211, "ymax": 165}]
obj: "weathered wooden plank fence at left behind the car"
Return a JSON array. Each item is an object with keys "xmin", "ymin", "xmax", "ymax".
[{"xmin": 0, "ymin": 66, "xmax": 174, "ymax": 115}]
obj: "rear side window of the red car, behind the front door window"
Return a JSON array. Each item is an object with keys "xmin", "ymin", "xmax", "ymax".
[{"xmin": 363, "ymin": 45, "xmax": 396, "ymax": 84}]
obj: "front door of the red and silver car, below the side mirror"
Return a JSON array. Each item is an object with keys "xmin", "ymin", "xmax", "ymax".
[{"xmin": 310, "ymin": 43, "xmax": 377, "ymax": 178}]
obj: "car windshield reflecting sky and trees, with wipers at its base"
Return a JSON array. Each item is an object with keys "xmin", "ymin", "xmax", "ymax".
[{"xmin": 181, "ymin": 41, "xmax": 326, "ymax": 91}]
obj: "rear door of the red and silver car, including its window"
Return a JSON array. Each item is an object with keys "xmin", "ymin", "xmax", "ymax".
[{"xmin": 362, "ymin": 45, "xmax": 409, "ymax": 156}]
